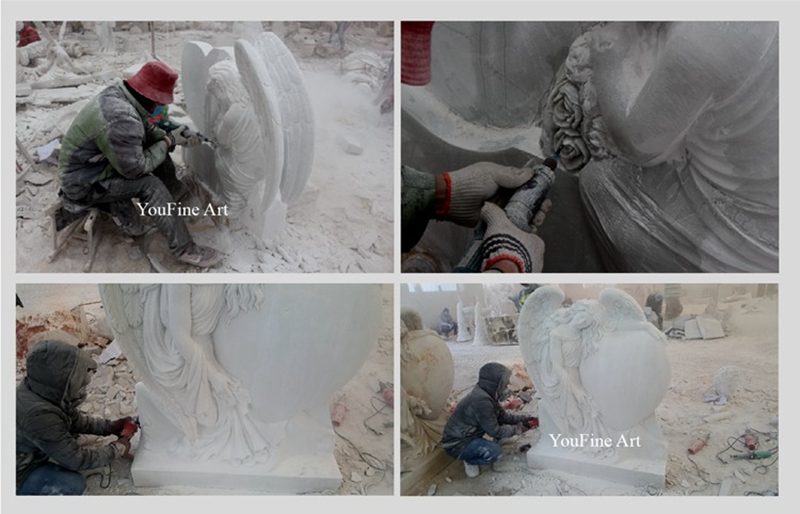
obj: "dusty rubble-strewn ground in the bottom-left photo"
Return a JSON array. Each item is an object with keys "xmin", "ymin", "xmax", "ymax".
[{"xmin": 17, "ymin": 284, "xmax": 394, "ymax": 495}]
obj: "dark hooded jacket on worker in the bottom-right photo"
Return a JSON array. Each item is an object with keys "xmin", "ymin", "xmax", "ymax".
[{"xmin": 442, "ymin": 362, "xmax": 527, "ymax": 459}]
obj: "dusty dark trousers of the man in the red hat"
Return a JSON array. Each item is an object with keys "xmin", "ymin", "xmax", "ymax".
[{"xmin": 80, "ymin": 156, "xmax": 192, "ymax": 257}]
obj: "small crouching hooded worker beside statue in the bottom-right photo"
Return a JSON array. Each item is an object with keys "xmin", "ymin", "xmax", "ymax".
[{"xmin": 442, "ymin": 362, "xmax": 538, "ymax": 478}]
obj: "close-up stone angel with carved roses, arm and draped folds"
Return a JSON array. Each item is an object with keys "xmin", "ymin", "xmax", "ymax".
[{"xmin": 540, "ymin": 22, "xmax": 778, "ymax": 272}]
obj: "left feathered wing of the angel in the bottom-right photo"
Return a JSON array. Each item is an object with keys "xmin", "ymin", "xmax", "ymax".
[{"xmin": 517, "ymin": 286, "xmax": 564, "ymax": 387}]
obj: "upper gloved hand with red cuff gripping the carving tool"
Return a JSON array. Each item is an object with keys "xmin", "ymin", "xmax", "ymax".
[{"xmin": 437, "ymin": 162, "xmax": 533, "ymax": 227}]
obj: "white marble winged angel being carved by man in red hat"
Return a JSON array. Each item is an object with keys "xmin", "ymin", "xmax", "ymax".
[{"xmin": 182, "ymin": 32, "xmax": 315, "ymax": 239}]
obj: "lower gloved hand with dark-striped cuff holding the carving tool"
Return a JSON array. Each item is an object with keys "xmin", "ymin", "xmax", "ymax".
[{"xmin": 481, "ymin": 203, "xmax": 544, "ymax": 273}]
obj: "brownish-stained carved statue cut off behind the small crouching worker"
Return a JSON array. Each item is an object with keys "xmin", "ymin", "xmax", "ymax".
[{"xmin": 400, "ymin": 308, "xmax": 454, "ymax": 465}]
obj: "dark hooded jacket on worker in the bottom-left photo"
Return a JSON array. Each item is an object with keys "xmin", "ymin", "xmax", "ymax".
[{"xmin": 17, "ymin": 340, "xmax": 116, "ymax": 491}]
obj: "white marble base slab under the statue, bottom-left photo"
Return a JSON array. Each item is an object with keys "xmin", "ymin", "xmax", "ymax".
[{"xmin": 131, "ymin": 434, "xmax": 342, "ymax": 494}]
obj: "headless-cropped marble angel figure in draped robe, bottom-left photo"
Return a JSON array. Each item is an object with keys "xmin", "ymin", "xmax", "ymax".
[{"xmin": 101, "ymin": 284, "xmax": 270, "ymax": 462}]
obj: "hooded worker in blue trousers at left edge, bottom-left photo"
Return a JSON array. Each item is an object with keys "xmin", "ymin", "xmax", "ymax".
[{"xmin": 17, "ymin": 340, "xmax": 135, "ymax": 495}]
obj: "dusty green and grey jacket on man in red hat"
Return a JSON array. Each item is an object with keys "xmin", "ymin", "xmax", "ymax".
[{"xmin": 58, "ymin": 82, "xmax": 169, "ymax": 201}]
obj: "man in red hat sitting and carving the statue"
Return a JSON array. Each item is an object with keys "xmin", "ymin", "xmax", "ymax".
[{"xmin": 56, "ymin": 62, "xmax": 222, "ymax": 267}]
